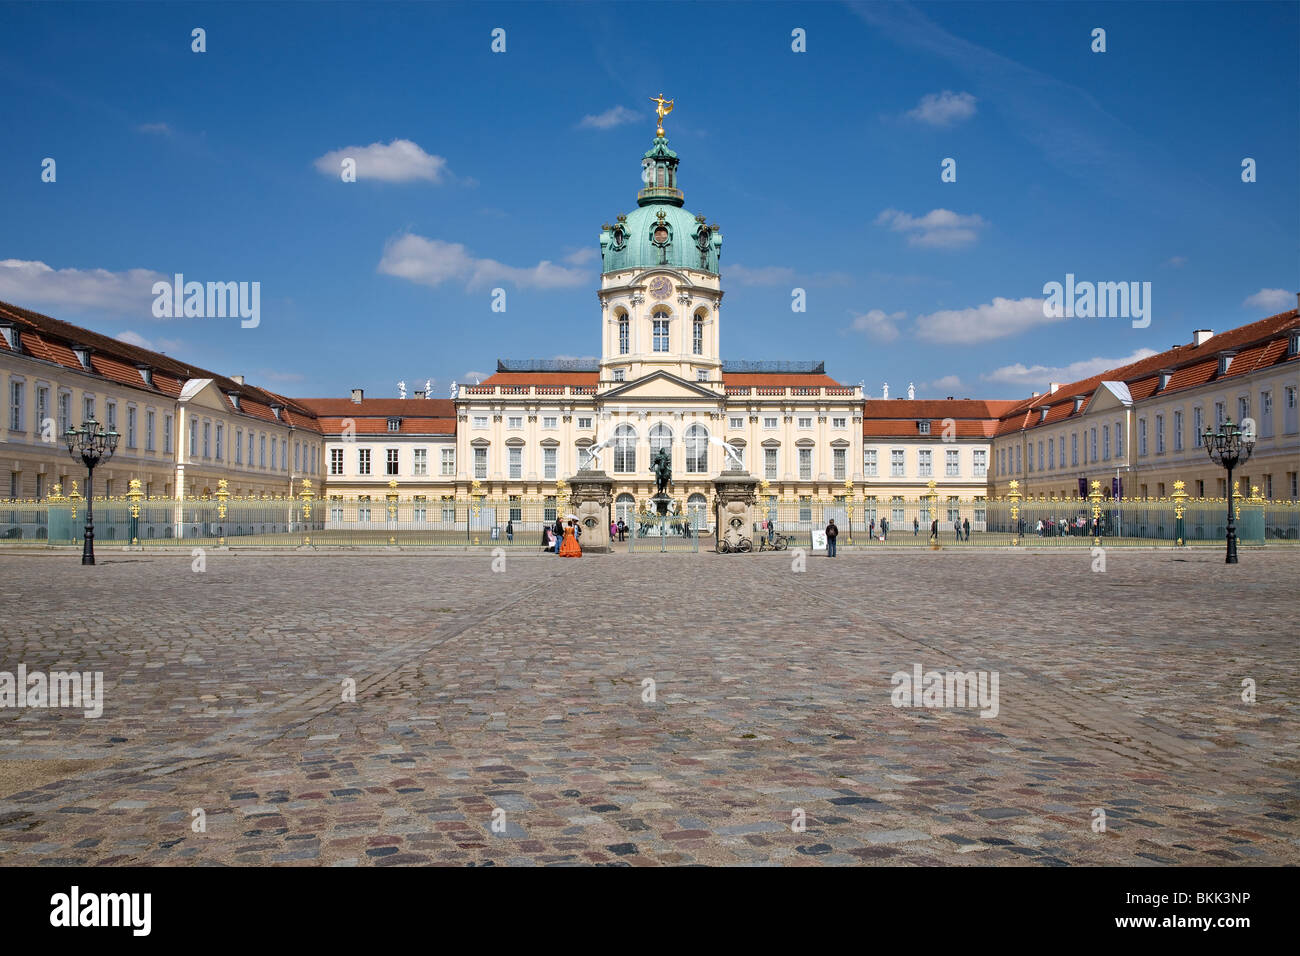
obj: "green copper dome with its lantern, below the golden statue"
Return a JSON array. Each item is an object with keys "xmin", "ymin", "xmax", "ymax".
[{"xmin": 601, "ymin": 137, "xmax": 723, "ymax": 274}]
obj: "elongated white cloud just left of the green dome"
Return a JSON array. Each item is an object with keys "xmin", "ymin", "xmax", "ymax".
[{"xmin": 378, "ymin": 233, "xmax": 592, "ymax": 289}]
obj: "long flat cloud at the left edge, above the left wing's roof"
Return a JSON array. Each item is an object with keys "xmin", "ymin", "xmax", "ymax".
[{"xmin": 0, "ymin": 259, "xmax": 172, "ymax": 316}]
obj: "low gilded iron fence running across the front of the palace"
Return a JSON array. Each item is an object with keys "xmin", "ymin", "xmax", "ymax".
[{"xmin": 0, "ymin": 492, "xmax": 1300, "ymax": 551}]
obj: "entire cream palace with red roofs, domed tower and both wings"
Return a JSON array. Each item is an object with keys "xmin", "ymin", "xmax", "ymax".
[{"xmin": 0, "ymin": 98, "xmax": 1300, "ymax": 531}]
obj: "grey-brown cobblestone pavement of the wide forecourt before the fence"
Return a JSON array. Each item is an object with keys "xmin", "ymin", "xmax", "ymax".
[{"xmin": 0, "ymin": 549, "xmax": 1300, "ymax": 866}]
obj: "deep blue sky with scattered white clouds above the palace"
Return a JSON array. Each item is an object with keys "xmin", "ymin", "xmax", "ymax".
[{"xmin": 0, "ymin": 3, "xmax": 1300, "ymax": 398}]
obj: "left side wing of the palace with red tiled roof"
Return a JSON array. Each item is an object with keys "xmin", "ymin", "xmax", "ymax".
[{"xmin": 0, "ymin": 302, "xmax": 324, "ymax": 499}]
